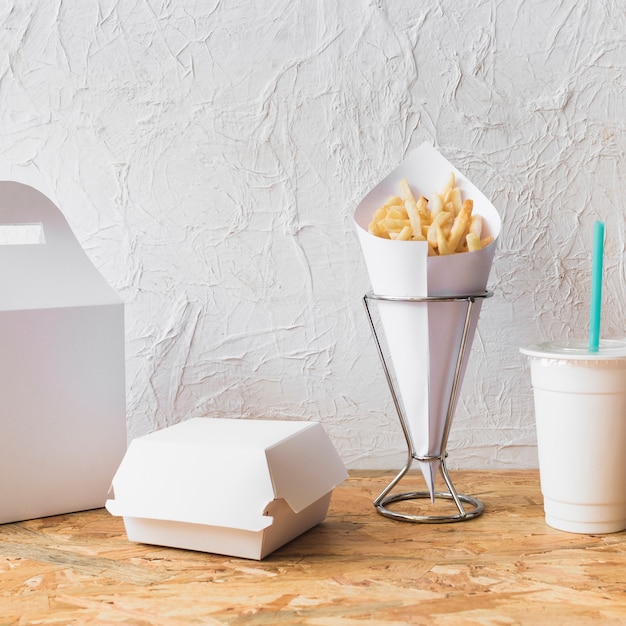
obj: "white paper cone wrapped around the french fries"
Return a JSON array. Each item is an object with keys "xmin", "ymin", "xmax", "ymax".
[{"xmin": 354, "ymin": 143, "xmax": 501, "ymax": 498}]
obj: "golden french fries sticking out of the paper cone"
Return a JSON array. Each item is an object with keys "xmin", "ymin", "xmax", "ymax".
[{"xmin": 368, "ymin": 172, "xmax": 493, "ymax": 256}]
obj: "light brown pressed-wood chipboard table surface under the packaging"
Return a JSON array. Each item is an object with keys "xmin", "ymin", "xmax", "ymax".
[{"xmin": 0, "ymin": 471, "xmax": 626, "ymax": 626}]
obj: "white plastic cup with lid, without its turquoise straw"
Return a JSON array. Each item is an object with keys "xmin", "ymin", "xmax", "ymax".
[{"xmin": 520, "ymin": 340, "xmax": 626, "ymax": 534}]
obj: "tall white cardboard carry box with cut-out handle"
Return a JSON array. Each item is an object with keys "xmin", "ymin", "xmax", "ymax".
[{"xmin": 0, "ymin": 182, "xmax": 126, "ymax": 523}]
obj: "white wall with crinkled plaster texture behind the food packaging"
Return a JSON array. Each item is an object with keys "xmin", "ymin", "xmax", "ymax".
[{"xmin": 0, "ymin": 0, "xmax": 626, "ymax": 468}]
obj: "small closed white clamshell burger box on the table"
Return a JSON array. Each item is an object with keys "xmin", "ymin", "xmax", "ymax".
[{"xmin": 106, "ymin": 417, "xmax": 347, "ymax": 560}]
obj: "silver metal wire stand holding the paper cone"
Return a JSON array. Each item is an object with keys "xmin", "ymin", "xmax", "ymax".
[{"xmin": 363, "ymin": 291, "xmax": 493, "ymax": 524}]
